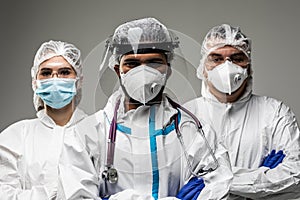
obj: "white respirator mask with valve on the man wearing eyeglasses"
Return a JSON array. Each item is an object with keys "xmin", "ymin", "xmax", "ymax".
[{"xmin": 207, "ymin": 60, "xmax": 248, "ymax": 95}]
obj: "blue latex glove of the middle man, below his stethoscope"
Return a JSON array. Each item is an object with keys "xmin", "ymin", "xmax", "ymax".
[{"xmin": 176, "ymin": 177, "xmax": 205, "ymax": 200}]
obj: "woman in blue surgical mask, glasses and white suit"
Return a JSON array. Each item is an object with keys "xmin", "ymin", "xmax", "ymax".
[{"xmin": 0, "ymin": 40, "xmax": 86, "ymax": 200}]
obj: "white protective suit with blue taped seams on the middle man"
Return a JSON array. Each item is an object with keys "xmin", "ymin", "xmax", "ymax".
[{"xmin": 60, "ymin": 90, "xmax": 232, "ymax": 200}]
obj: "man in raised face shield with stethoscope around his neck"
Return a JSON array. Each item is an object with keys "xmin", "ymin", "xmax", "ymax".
[{"xmin": 60, "ymin": 18, "xmax": 232, "ymax": 200}]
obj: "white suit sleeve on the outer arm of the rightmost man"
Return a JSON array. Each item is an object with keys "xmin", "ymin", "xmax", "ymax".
[{"xmin": 231, "ymin": 103, "xmax": 300, "ymax": 199}]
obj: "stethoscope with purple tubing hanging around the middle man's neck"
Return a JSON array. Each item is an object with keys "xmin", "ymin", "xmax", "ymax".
[{"xmin": 102, "ymin": 97, "xmax": 219, "ymax": 188}]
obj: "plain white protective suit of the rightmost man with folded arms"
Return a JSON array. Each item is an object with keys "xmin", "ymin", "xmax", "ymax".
[{"xmin": 184, "ymin": 77, "xmax": 300, "ymax": 200}]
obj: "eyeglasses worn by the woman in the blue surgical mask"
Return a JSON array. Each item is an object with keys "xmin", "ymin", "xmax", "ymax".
[{"xmin": 37, "ymin": 67, "xmax": 76, "ymax": 79}]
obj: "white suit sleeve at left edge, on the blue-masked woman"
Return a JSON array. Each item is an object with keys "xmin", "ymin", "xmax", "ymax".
[{"xmin": 0, "ymin": 121, "xmax": 49, "ymax": 200}]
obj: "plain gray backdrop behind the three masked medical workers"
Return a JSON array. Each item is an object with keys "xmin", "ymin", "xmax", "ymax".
[{"xmin": 0, "ymin": 0, "xmax": 300, "ymax": 131}]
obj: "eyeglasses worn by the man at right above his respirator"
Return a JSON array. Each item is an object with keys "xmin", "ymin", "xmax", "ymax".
[{"xmin": 206, "ymin": 53, "xmax": 250, "ymax": 67}]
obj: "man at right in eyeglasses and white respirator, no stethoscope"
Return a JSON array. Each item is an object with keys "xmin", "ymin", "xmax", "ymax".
[{"xmin": 184, "ymin": 24, "xmax": 300, "ymax": 199}]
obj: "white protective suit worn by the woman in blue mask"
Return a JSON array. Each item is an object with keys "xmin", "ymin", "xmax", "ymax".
[{"xmin": 0, "ymin": 108, "xmax": 86, "ymax": 200}]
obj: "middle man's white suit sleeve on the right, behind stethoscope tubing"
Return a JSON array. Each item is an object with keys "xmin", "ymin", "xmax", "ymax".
[{"xmin": 182, "ymin": 118, "xmax": 233, "ymax": 200}]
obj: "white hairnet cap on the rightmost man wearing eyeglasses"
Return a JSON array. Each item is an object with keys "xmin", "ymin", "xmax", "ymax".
[{"xmin": 197, "ymin": 24, "xmax": 251, "ymax": 79}]
